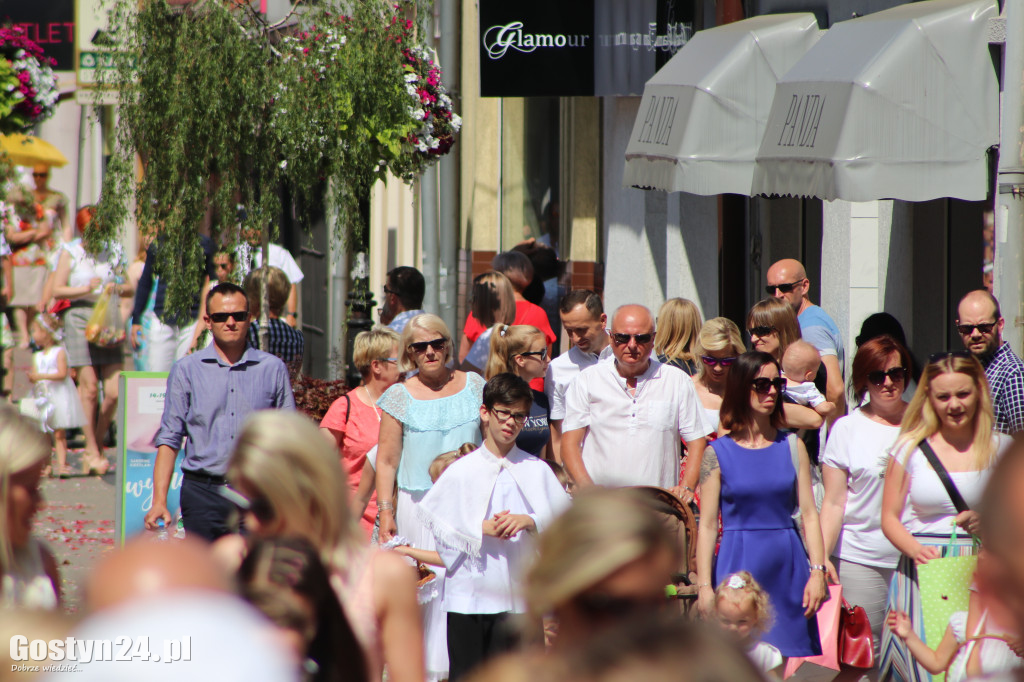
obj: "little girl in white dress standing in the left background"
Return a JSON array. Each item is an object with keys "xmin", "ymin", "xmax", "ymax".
[{"xmin": 29, "ymin": 312, "xmax": 88, "ymax": 478}]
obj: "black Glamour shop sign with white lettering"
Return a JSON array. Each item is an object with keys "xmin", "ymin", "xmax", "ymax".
[{"xmin": 479, "ymin": 0, "xmax": 693, "ymax": 97}]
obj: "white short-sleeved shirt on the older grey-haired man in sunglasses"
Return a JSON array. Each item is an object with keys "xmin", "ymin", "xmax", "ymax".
[{"xmin": 562, "ymin": 360, "xmax": 712, "ymax": 487}]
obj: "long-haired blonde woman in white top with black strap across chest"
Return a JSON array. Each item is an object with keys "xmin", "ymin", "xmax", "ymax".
[{"xmin": 880, "ymin": 351, "xmax": 1011, "ymax": 680}]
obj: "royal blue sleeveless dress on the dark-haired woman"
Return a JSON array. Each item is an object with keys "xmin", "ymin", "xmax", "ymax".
[{"xmin": 714, "ymin": 433, "xmax": 821, "ymax": 656}]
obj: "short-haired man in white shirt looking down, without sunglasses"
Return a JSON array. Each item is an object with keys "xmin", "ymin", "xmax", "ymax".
[{"xmin": 544, "ymin": 289, "xmax": 611, "ymax": 460}]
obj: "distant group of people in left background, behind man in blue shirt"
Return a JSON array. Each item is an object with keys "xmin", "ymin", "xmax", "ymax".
[{"xmin": 0, "ymin": 165, "xmax": 304, "ymax": 477}]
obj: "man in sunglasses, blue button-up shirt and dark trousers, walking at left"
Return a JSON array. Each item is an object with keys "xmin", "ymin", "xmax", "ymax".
[{"xmin": 145, "ymin": 282, "xmax": 295, "ymax": 542}]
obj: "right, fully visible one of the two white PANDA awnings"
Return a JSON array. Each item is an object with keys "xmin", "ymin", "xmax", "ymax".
[{"xmin": 754, "ymin": 0, "xmax": 999, "ymax": 202}]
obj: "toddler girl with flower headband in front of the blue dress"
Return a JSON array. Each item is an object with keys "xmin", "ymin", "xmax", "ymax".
[{"xmin": 715, "ymin": 570, "xmax": 782, "ymax": 679}]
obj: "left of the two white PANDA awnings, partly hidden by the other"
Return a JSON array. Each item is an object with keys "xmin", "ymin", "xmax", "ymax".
[{"xmin": 624, "ymin": 13, "xmax": 820, "ymax": 195}]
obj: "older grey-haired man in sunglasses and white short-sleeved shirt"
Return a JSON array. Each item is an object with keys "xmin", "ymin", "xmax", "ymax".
[{"xmin": 561, "ymin": 305, "xmax": 713, "ymax": 502}]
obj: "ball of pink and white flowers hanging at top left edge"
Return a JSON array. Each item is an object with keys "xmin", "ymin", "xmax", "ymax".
[{"xmin": 0, "ymin": 27, "xmax": 60, "ymax": 134}]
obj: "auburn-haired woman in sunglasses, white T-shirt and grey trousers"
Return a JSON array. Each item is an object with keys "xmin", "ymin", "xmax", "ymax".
[{"xmin": 821, "ymin": 336, "xmax": 910, "ymax": 677}]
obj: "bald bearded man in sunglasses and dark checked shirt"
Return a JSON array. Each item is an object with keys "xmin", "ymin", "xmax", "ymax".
[{"xmin": 956, "ymin": 289, "xmax": 1024, "ymax": 435}]
